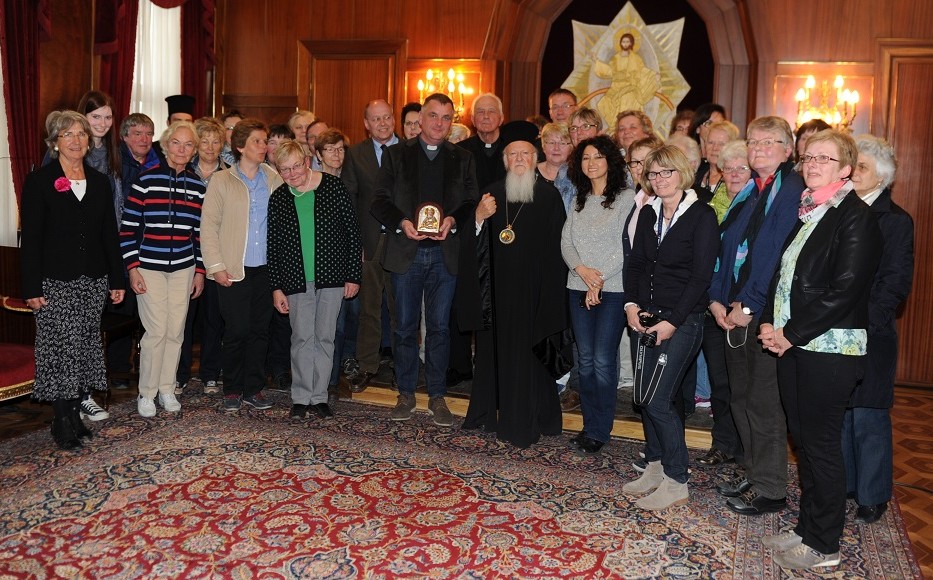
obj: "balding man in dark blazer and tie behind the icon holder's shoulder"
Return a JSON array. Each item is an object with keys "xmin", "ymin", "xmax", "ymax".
[{"xmin": 340, "ymin": 99, "xmax": 399, "ymax": 393}]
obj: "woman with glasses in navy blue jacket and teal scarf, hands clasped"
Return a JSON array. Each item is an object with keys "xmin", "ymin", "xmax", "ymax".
[{"xmin": 709, "ymin": 115, "xmax": 805, "ymax": 515}]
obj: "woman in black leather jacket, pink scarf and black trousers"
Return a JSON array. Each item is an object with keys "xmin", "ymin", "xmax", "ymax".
[{"xmin": 758, "ymin": 129, "xmax": 884, "ymax": 570}]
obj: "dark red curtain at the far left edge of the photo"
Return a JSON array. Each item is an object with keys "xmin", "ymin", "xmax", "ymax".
[{"xmin": 0, "ymin": 0, "xmax": 45, "ymax": 204}]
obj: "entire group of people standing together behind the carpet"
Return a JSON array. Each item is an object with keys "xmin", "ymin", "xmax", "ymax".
[{"xmin": 22, "ymin": 84, "xmax": 913, "ymax": 568}]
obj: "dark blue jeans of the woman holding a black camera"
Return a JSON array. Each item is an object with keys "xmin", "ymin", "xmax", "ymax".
[{"xmin": 632, "ymin": 313, "xmax": 703, "ymax": 483}]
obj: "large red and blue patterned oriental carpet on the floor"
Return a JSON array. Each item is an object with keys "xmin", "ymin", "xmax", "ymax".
[{"xmin": 0, "ymin": 393, "xmax": 920, "ymax": 578}]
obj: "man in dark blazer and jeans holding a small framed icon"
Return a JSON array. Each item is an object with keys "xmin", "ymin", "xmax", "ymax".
[{"xmin": 372, "ymin": 93, "xmax": 478, "ymax": 426}]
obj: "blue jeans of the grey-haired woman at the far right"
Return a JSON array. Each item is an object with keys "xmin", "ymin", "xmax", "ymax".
[{"xmin": 842, "ymin": 407, "xmax": 894, "ymax": 505}]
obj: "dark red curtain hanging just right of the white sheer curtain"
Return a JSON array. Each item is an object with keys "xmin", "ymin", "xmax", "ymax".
[{"xmin": 180, "ymin": 0, "xmax": 215, "ymax": 119}]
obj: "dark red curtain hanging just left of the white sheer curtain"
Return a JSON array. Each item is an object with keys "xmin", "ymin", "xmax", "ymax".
[{"xmin": 94, "ymin": 0, "xmax": 139, "ymax": 119}]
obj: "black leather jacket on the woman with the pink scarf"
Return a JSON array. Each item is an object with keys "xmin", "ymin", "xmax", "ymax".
[{"xmin": 761, "ymin": 184, "xmax": 882, "ymax": 346}]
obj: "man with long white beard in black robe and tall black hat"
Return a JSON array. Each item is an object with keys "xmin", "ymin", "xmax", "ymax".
[{"xmin": 461, "ymin": 141, "xmax": 568, "ymax": 447}]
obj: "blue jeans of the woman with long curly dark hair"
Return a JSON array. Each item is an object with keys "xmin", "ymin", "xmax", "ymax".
[{"xmin": 568, "ymin": 290, "xmax": 625, "ymax": 443}]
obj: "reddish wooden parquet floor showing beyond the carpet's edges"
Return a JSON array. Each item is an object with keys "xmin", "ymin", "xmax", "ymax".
[{"xmin": 0, "ymin": 387, "xmax": 933, "ymax": 579}]
